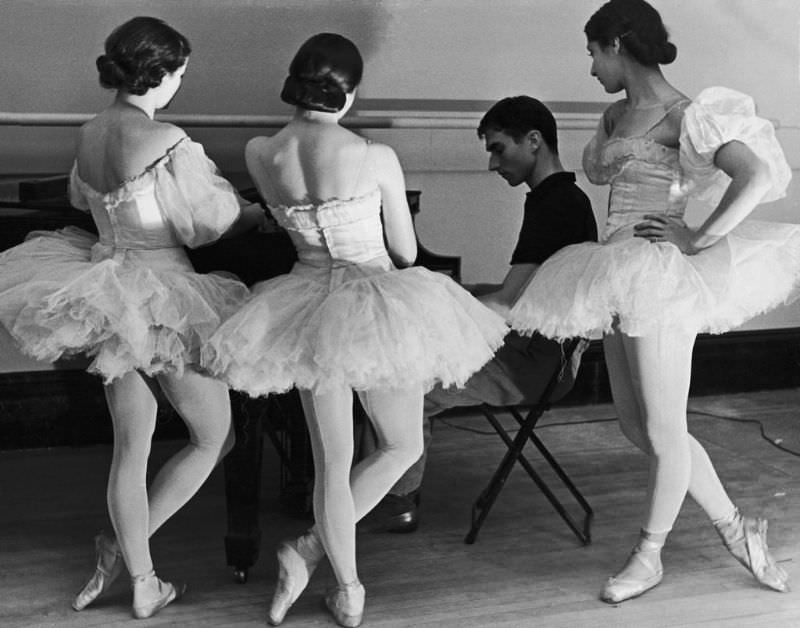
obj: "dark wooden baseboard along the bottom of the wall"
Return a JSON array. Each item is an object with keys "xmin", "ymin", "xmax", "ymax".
[{"xmin": 0, "ymin": 327, "xmax": 800, "ymax": 449}]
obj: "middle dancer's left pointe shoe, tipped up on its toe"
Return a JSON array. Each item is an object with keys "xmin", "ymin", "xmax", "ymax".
[{"xmin": 267, "ymin": 532, "xmax": 325, "ymax": 626}]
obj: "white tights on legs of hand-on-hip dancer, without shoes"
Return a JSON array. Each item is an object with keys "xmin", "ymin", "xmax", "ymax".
[{"xmin": 603, "ymin": 324, "xmax": 736, "ymax": 533}]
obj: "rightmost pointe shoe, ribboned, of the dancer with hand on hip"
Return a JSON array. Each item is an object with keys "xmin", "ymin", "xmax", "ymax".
[{"xmin": 714, "ymin": 510, "xmax": 790, "ymax": 593}]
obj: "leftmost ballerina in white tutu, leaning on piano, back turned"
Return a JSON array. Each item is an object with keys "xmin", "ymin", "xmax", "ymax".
[{"xmin": 0, "ymin": 17, "xmax": 264, "ymax": 618}]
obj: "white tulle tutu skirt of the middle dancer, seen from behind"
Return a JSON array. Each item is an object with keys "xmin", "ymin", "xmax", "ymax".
[{"xmin": 203, "ymin": 264, "xmax": 508, "ymax": 397}]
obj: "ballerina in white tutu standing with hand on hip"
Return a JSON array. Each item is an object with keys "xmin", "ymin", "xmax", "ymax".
[{"xmin": 511, "ymin": 0, "xmax": 800, "ymax": 603}]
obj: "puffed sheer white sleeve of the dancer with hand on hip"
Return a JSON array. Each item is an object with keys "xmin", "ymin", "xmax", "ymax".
[{"xmin": 680, "ymin": 87, "xmax": 792, "ymax": 204}]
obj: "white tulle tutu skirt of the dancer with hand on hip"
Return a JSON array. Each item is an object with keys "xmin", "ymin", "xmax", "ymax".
[{"xmin": 510, "ymin": 220, "xmax": 800, "ymax": 338}]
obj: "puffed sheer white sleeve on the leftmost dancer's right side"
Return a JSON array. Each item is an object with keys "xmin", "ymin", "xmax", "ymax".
[{"xmin": 154, "ymin": 138, "xmax": 241, "ymax": 247}]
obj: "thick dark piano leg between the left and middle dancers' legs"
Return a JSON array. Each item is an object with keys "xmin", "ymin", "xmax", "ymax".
[{"xmin": 224, "ymin": 391, "xmax": 267, "ymax": 583}]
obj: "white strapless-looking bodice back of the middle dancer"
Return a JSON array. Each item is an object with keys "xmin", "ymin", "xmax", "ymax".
[{"xmin": 270, "ymin": 188, "xmax": 389, "ymax": 268}]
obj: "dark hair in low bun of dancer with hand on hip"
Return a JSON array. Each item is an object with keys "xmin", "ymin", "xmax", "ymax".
[{"xmin": 583, "ymin": 0, "xmax": 678, "ymax": 66}]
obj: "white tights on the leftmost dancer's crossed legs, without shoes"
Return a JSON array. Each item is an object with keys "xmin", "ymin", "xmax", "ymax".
[{"xmin": 105, "ymin": 370, "xmax": 234, "ymax": 576}]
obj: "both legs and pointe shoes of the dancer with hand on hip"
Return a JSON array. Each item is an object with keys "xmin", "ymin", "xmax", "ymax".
[{"xmin": 602, "ymin": 326, "xmax": 789, "ymax": 601}]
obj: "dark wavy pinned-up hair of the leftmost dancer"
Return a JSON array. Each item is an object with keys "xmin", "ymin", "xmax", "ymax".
[{"xmin": 96, "ymin": 17, "xmax": 192, "ymax": 96}]
